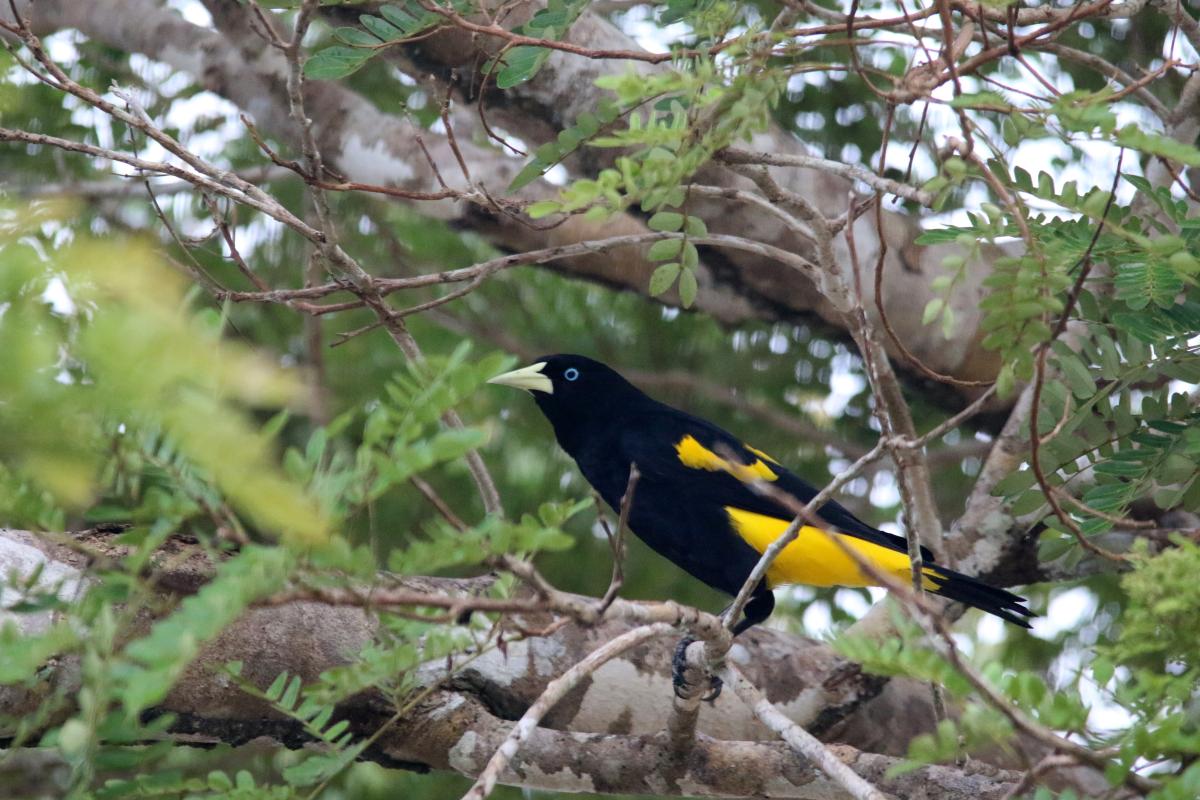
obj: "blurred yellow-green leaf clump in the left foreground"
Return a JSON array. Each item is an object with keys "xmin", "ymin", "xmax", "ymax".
[{"xmin": 0, "ymin": 210, "xmax": 326, "ymax": 542}]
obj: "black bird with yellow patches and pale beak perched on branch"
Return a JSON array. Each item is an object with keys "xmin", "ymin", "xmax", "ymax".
[{"xmin": 488, "ymin": 354, "xmax": 1034, "ymax": 692}]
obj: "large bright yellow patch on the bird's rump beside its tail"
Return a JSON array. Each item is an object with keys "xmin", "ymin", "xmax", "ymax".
[{"xmin": 725, "ymin": 506, "xmax": 937, "ymax": 589}]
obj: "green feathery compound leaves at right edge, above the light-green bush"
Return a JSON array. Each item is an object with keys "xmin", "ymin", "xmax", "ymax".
[{"xmin": 964, "ymin": 158, "xmax": 1200, "ymax": 560}]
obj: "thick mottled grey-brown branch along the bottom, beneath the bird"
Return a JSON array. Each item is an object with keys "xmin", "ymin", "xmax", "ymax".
[{"xmin": 0, "ymin": 531, "xmax": 1016, "ymax": 800}]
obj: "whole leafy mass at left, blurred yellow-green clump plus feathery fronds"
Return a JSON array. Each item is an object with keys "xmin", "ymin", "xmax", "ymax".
[{"xmin": 0, "ymin": 220, "xmax": 576, "ymax": 798}]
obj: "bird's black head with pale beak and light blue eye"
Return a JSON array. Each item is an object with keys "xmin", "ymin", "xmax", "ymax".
[{"xmin": 487, "ymin": 354, "xmax": 646, "ymax": 434}]
